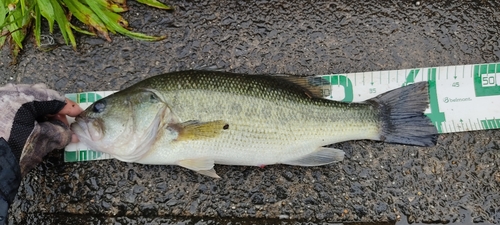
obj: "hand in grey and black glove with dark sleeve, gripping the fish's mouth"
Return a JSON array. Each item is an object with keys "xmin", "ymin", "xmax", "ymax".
[{"xmin": 0, "ymin": 84, "xmax": 82, "ymax": 225}]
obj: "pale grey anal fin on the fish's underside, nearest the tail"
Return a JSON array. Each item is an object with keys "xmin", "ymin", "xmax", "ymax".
[{"xmin": 283, "ymin": 147, "xmax": 344, "ymax": 166}]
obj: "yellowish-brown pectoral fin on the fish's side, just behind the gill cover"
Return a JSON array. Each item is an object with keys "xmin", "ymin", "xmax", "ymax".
[{"xmin": 169, "ymin": 120, "xmax": 229, "ymax": 141}]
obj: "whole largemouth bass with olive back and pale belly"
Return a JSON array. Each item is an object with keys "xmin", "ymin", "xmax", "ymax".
[{"xmin": 71, "ymin": 71, "xmax": 437, "ymax": 177}]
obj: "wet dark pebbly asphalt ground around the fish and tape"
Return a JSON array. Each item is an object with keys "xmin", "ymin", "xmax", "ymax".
[{"xmin": 0, "ymin": 0, "xmax": 500, "ymax": 224}]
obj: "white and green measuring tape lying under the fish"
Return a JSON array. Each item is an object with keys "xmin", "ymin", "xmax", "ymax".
[{"xmin": 64, "ymin": 63, "xmax": 500, "ymax": 162}]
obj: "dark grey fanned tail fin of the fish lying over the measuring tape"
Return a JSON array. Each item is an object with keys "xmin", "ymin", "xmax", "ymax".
[{"xmin": 367, "ymin": 82, "xmax": 438, "ymax": 146}]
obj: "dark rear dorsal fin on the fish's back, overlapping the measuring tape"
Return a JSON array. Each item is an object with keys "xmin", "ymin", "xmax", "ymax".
[{"xmin": 277, "ymin": 75, "xmax": 331, "ymax": 98}]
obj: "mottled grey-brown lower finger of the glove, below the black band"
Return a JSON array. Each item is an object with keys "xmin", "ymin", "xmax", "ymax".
[{"xmin": 19, "ymin": 120, "xmax": 72, "ymax": 176}]
